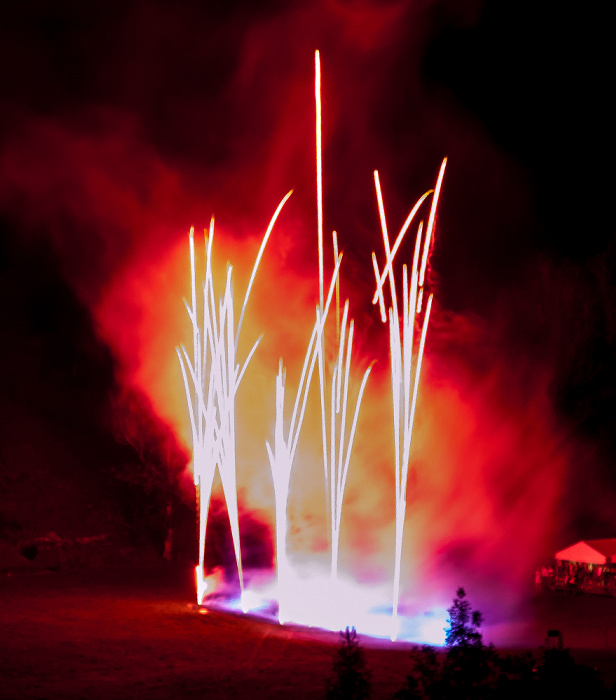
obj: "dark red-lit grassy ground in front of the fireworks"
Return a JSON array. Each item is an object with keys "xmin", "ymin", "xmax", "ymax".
[{"xmin": 0, "ymin": 565, "xmax": 616, "ymax": 699}]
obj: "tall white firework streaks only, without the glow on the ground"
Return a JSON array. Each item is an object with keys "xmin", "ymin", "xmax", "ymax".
[{"xmin": 178, "ymin": 51, "xmax": 446, "ymax": 640}]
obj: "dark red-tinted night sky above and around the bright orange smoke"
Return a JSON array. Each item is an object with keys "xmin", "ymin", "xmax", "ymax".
[{"xmin": 0, "ymin": 0, "xmax": 616, "ymax": 576}]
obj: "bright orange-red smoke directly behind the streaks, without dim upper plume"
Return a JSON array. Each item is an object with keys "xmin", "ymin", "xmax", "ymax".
[{"xmin": 91, "ymin": 193, "xmax": 576, "ymax": 624}]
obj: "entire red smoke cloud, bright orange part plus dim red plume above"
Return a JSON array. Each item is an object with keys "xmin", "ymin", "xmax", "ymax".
[{"xmin": 0, "ymin": 1, "xmax": 600, "ymax": 628}]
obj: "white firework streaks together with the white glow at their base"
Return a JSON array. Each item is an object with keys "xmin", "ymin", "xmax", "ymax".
[{"xmin": 177, "ymin": 51, "xmax": 446, "ymax": 643}]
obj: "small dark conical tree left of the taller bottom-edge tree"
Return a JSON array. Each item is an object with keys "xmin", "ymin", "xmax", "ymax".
[{"xmin": 327, "ymin": 627, "xmax": 371, "ymax": 700}]
